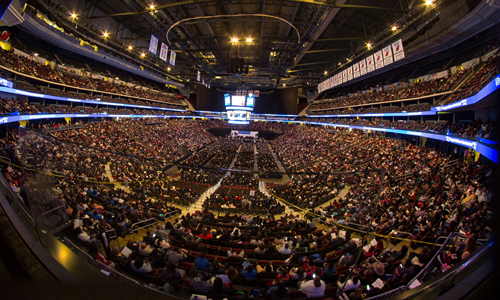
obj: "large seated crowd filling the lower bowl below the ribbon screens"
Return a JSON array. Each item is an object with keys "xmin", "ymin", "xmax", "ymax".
[{"xmin": 3, "ymin": 116, "xmax": 496, "ymax": 299}]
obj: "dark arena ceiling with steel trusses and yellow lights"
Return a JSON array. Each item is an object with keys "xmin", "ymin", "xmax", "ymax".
[{"xmin": 29, "ymin": 0, "xmax": 458, "ymax": 89}]
